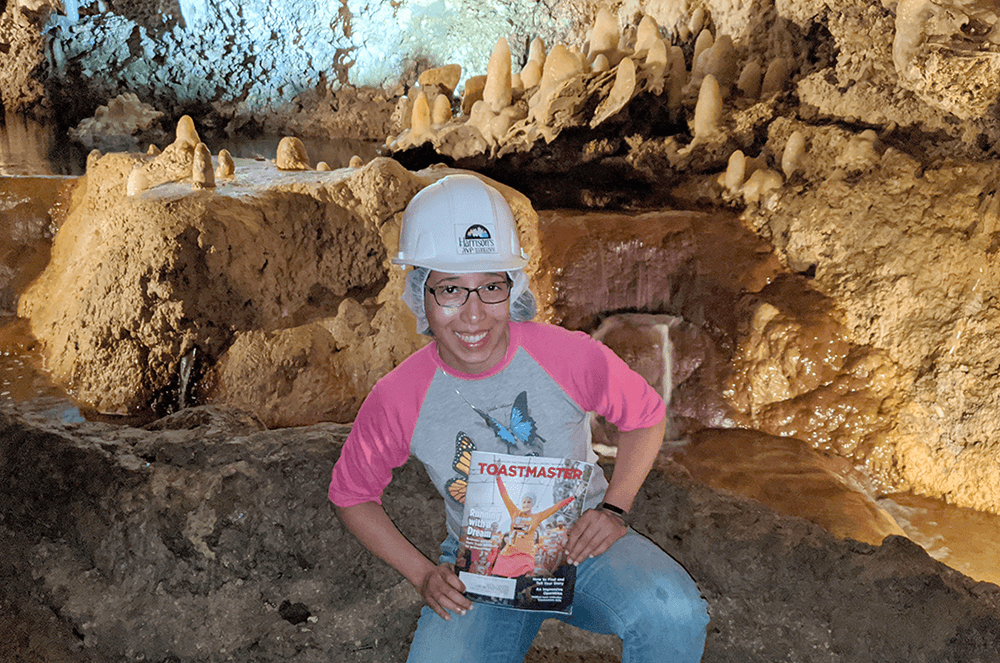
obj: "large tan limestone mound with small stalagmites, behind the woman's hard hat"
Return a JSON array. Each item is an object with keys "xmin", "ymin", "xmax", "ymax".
[{"xmin": 19, "ymin": 155, "xmax": 538, "ymax": 426}]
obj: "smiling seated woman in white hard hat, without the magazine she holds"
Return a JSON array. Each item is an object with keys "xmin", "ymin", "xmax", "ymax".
[{"xmin": 329, "ymin": 175, "xmax": 709, "ymax": 663}]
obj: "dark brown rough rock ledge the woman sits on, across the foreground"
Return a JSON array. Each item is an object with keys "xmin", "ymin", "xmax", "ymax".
[{"xmin": 0, "ymin": 408, "xmax": 1000, "ymax": 662}]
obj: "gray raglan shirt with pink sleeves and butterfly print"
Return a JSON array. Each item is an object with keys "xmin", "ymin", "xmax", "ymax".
[{"xmin": 330, "ymin": 323, "xmax": 665, "ymax": 538}]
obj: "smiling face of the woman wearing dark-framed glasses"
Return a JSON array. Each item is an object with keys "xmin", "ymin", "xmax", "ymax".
[{"xmin": 424, "ymin": 271, "xmax": 510, "ymax": 373}]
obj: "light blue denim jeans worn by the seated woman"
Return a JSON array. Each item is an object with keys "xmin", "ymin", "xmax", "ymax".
[{"xmin": 407, "ymin": 529, "xmax": 708, "ymax": 663}]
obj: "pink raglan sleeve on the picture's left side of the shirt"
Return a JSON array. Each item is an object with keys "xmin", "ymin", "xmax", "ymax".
[{"xmin": 329, "ymin": 352, "xmax": 426, "ymax": 507}]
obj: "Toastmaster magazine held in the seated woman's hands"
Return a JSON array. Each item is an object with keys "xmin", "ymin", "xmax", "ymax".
[{"xmin": 455, "ymin": 451, "xmax": 597, "ymax": 614}]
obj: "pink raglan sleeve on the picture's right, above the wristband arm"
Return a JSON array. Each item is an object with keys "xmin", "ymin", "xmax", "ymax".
[{"xmin": 524, "ymin": 323, "xmax": 667, "ymax": 431}]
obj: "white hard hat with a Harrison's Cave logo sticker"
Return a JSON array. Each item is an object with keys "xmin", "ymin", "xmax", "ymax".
[{"xmin": 392, "ymin": 175, "xmax": 528, "ymax": 274}]
